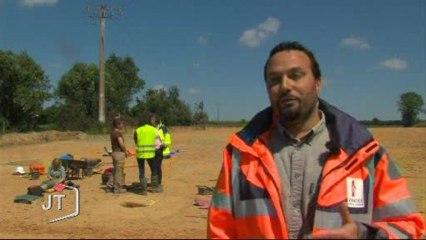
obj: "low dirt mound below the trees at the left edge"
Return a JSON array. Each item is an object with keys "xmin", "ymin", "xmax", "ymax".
[{"xmin": 0, "ymin": 131, "xmax": 87, "ymax": 147}]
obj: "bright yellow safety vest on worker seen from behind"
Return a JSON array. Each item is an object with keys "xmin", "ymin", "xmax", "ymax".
[{"xmin": 136, "ymin": 124, "xmax": 157, "ymax": 159}]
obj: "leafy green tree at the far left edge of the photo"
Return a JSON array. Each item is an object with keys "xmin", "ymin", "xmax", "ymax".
[{"xmin": 0, "ymin": 50, "xmax": 51, "ymax": 130}]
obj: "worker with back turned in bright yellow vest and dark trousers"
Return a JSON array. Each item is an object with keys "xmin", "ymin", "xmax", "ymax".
[{"xmin": 133, "ymin": 115, "xmax": 158, "ymax": 195}]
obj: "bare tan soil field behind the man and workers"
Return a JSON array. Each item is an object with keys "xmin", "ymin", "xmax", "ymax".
[{"xmin": 0, "ymin": 128, "xmax": 426, "ymax": 239}]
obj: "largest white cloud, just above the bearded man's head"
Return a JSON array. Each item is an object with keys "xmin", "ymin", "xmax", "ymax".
[{"xmin": 240, "ymin": 17, "xmax": 281, "ymax": 48}]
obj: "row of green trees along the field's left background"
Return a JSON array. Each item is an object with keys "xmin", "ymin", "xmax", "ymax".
[{"xmin": 0, "ymin": 50, "xmax": 208, "ymax": 132}]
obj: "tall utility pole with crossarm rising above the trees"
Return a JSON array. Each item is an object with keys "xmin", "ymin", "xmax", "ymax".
[{"xmin": 86, "ymin": 4, "xmax": 121, "ymax": 123}]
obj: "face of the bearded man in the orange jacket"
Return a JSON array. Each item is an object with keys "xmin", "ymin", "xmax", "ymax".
[{"xmin": 266, "ymin": 50, "xmax": 321, "ymax": 124}]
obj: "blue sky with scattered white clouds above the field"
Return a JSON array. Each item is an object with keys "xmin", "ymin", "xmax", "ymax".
[{"xmin": 0, "ymin": 0, "xmax": 426, "ymax": 120}]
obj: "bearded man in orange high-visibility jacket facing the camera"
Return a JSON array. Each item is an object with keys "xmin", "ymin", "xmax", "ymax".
[{"xmin": 208, "ymin": 42, "xmax": 424, "ymax": 239}]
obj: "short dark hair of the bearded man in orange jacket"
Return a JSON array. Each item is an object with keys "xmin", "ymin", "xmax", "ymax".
[{"xmin": 263, "ymin": 41, "xmax": 321, "ymax": 82}]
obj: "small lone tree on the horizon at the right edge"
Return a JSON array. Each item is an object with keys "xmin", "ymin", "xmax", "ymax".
[{"xmin": 398, "ymin": 92, "xmax": 423, "ymax": 127}]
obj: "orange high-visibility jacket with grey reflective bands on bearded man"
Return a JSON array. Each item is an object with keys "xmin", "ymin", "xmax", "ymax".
[{"xmin": 208, "ymin": 100, "xmax": 424, "ymax": 239}]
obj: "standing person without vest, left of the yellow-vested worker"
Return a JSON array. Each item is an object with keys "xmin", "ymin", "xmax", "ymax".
[{"xmin": 106, "ymin": 118, "xmax": 127, "ymax": 194}]
